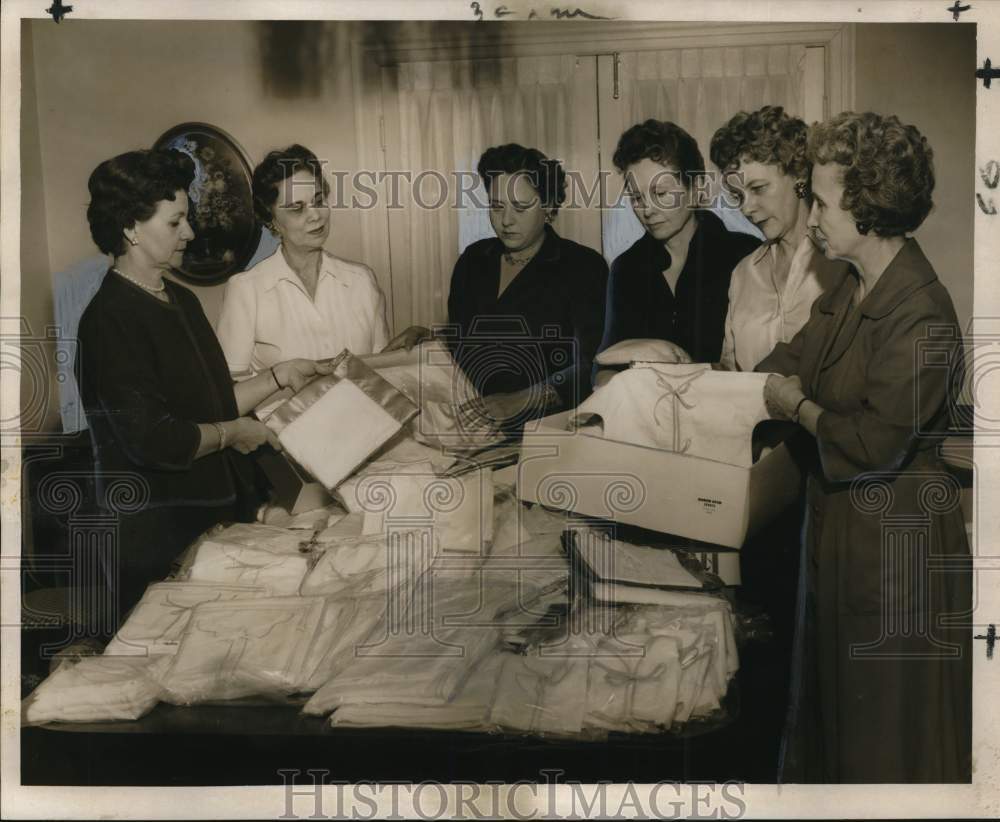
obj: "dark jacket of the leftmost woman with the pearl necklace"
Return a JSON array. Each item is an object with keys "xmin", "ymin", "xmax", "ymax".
[{"xmin": 77, "ymin": 274, "xmax": 256, "ymax": 516}]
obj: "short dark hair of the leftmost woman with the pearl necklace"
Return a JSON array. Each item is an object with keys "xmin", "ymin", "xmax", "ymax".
[{"xmin": 87, "ymin": 149, "xmax": 195, "ymax": 257}]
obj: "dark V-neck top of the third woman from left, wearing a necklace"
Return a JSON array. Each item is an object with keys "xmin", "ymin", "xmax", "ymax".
[{"xmin": 448, "ymin": 228, "xmax": 608, "ymax": 408}]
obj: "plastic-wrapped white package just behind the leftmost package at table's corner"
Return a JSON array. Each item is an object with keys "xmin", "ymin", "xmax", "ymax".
[{"xmin": 104, "ymin": 582, "xmax": 268, "ymax": 656}]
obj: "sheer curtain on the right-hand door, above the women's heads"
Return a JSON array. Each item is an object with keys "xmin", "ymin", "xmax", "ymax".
[{"xmin": 601, "ymin": 45, "xmax": 806, "ymax": 260}]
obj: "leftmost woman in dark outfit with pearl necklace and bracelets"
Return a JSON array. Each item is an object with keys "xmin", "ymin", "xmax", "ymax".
[{"xmin": 77, "ymin": 151, "xmax": 332, "ymax": 632}]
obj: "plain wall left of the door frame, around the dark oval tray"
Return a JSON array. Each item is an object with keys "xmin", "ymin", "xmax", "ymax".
[{"xmin": 23, "ymin": 18, "xmax": 372, "ymax": 320}]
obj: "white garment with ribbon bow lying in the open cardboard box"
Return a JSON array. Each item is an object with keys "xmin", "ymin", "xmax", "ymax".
[{"xmin": 570, "ymin": 363, "xmax": 770, "ymax": 467}]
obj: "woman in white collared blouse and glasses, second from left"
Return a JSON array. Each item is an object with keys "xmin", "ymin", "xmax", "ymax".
[{"xmin": 216, "ymin": 144, "xmax": 406, "ymax": 378}]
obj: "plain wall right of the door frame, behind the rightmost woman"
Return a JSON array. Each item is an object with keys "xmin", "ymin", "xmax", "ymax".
[{"xmin": 855, "ymin": 23, "xmax": 976, "ymax": 329}]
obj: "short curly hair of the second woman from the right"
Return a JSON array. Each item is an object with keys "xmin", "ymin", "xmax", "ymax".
[{"xmin": 709, "ymin": 106, "xmax": 809, "ymax": 180}]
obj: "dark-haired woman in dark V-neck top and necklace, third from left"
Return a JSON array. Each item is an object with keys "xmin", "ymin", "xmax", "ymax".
[{"xmin": 448, "ymin": 143, "xmax": 608, "ymax": 426}]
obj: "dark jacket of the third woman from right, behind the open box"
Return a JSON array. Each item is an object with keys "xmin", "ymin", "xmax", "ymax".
[{"xmin": 598, "ymin": 211, "xmax": 760, "ymax": 362}]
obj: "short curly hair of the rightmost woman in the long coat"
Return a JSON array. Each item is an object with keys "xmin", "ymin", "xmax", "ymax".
[{"xmin": 808, "ymin": 111, "xmax": 934, "ymax": 237}]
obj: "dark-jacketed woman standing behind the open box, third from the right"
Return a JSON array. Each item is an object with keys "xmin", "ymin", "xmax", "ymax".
[{"xmin": 596, "ymin": 120, "xmax": 759, "ymax": 383}]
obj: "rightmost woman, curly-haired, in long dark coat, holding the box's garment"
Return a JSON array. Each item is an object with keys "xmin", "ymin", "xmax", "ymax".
[{"xmin": 757, "ymin": 112, "xmax": 971, "ymax": 782}]
